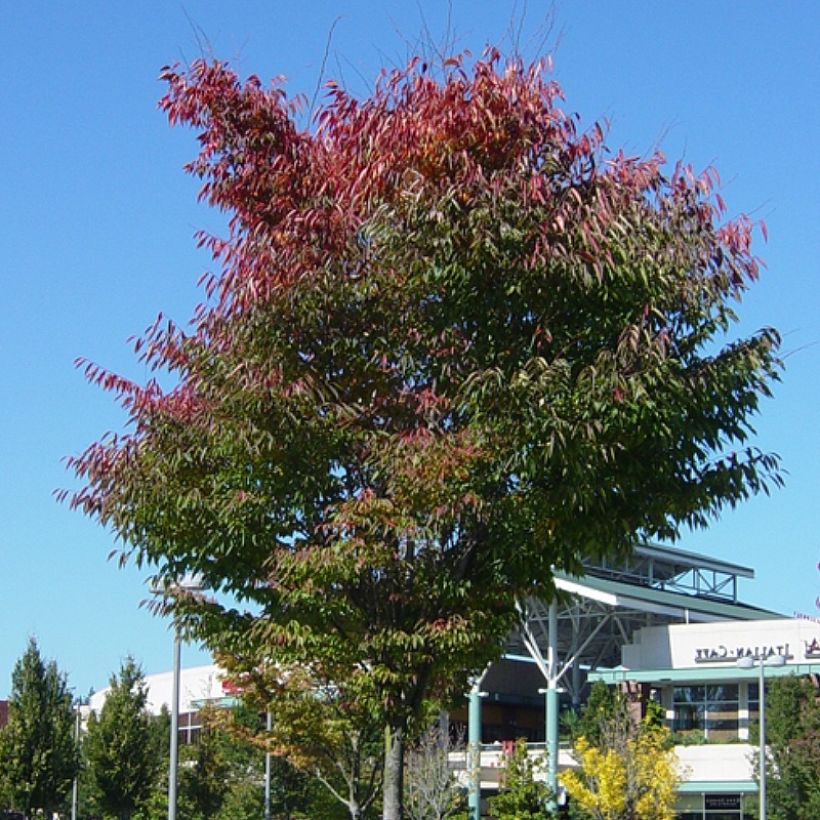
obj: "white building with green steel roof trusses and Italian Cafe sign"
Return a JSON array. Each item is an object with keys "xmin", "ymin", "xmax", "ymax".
[{"xmin": 452, "ymin": 545, "xmax": 820, "ymax": 820}]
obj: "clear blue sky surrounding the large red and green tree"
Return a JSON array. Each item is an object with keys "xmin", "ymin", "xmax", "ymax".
[{"xmin": 0, "ymin": 0, "xmax": 820, "ymax": 697}]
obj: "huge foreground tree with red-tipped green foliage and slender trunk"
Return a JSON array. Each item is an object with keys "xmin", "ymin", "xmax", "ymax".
[{"xmin": 70, "ymin": 49, "xmax": 780, "ymax": 820}]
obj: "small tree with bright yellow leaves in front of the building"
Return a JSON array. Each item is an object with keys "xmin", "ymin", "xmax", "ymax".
[{"xmin": 560, "ymin": 684, "xmax": 679, "ymax": 820}]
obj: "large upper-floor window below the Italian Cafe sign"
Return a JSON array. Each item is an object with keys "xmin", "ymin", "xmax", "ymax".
[{"xmin": 672, "ymin": 684, "xmax": 738, "ymax": 742}]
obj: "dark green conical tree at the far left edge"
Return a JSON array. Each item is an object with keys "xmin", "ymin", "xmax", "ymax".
[{"xmin": 0, "ymin": 638, "xmax": 78, "ymax": 817}]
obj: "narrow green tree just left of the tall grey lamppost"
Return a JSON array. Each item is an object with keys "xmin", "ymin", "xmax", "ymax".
[{"xmin": 83, "ymin": 657, "xmax": 163, "ymax": 820}]
